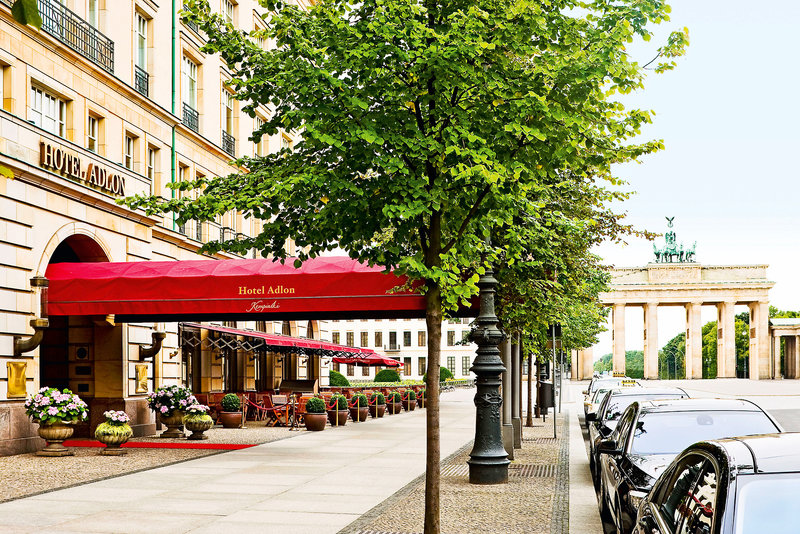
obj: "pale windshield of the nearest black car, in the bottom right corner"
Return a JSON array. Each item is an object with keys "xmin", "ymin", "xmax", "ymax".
[{"xmin": 733, "ymin": 473, "xmax": 800, "ymax": 534}]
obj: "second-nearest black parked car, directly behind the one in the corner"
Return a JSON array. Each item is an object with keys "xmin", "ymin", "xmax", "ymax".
[{"xmin": 597, "ymin": 399, "xmax": 782, "ymax": 533}]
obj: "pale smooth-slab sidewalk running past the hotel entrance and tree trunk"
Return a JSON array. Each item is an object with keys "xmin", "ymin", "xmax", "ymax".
[{"xmin": 0, "ymin": 389, "xmax": 475, "ymax": 534}]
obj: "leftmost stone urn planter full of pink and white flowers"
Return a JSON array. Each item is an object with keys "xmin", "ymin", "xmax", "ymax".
[{"xmin": 25, "ymin": 387, "xmax": 89, "ymax": 456}]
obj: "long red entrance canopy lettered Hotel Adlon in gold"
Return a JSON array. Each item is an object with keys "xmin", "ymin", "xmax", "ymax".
[{"xmin": 46, "ymin": 257, "xmax": 450, "ymax": 322}]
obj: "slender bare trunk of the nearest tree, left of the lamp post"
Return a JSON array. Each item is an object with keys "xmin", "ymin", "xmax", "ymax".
[{"xmin": 425, "ymin": 287, "xmax": 442, "ymax": 534}]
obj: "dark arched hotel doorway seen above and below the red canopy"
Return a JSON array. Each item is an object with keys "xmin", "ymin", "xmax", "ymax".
[{"xmin": 39, "ymin": 234, "xmax": 111, "ymax": 435}]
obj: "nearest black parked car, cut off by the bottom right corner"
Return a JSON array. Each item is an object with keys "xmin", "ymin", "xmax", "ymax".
[{"xmin": 636, "ymin": 433, "xmax": 800, "ymax": 534}]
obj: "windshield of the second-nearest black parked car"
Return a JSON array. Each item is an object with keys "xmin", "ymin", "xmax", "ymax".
[{"xmin": 631, "ymin": 410, "xmax": 779, "ymax": 454}]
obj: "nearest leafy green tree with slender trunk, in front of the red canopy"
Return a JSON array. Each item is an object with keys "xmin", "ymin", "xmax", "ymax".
[{"xmin": 127, "ymin": 0, "xmax": 687, "ymax": 534}]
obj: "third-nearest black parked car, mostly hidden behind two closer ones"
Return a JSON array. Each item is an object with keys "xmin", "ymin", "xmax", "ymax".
[{"xmin": 586, "ymin": 387, "xmax": 689, "ymax": 490}]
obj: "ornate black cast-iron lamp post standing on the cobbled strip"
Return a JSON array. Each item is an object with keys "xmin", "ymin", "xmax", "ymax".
[{"xmin": 467, "ymin": 270, "xmax": 511, "ymax": 484}]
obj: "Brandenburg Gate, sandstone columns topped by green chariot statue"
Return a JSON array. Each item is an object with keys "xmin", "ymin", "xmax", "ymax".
[{"xmin": 578, "ymin": 218, "xmax": 775, "ymax": 379}]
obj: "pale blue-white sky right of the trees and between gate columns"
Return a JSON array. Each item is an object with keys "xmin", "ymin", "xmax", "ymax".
[{"xmin": 594, "ymin": 0, "xmax": 800, "ymax": 358}]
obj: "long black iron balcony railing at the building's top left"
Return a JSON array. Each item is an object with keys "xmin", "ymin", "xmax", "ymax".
[{"xmin": 0, "ymin": 0, "xmax": 114, "ymax": 74}]
